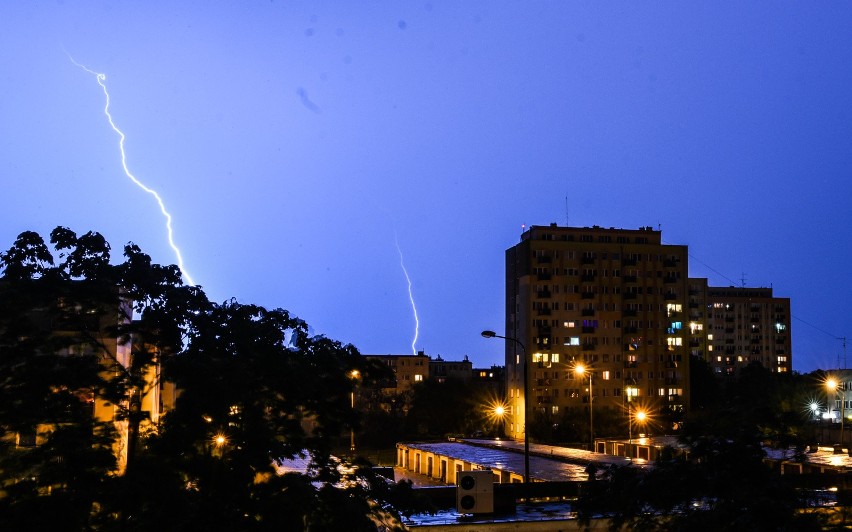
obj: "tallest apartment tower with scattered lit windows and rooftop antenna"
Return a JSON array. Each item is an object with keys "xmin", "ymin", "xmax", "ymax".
[{"xmin": 505, "ymin": 224, "xmax": 690, "ymax": 439}]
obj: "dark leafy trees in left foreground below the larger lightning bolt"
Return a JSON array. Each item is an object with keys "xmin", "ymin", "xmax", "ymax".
[{"xmin": 0, "ymin": 228, "xmax": 417, "ymax": 531}]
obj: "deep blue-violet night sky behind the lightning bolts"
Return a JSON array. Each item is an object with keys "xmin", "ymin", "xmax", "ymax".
[{"xmin": 0, "ymin": 0, "xmax": 852, "ymax": 371}]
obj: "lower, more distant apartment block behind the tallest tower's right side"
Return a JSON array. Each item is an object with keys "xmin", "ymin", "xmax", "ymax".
[{"xmin": 689, "ymin": 278, "xmax": 793, "ymax": 377}]
